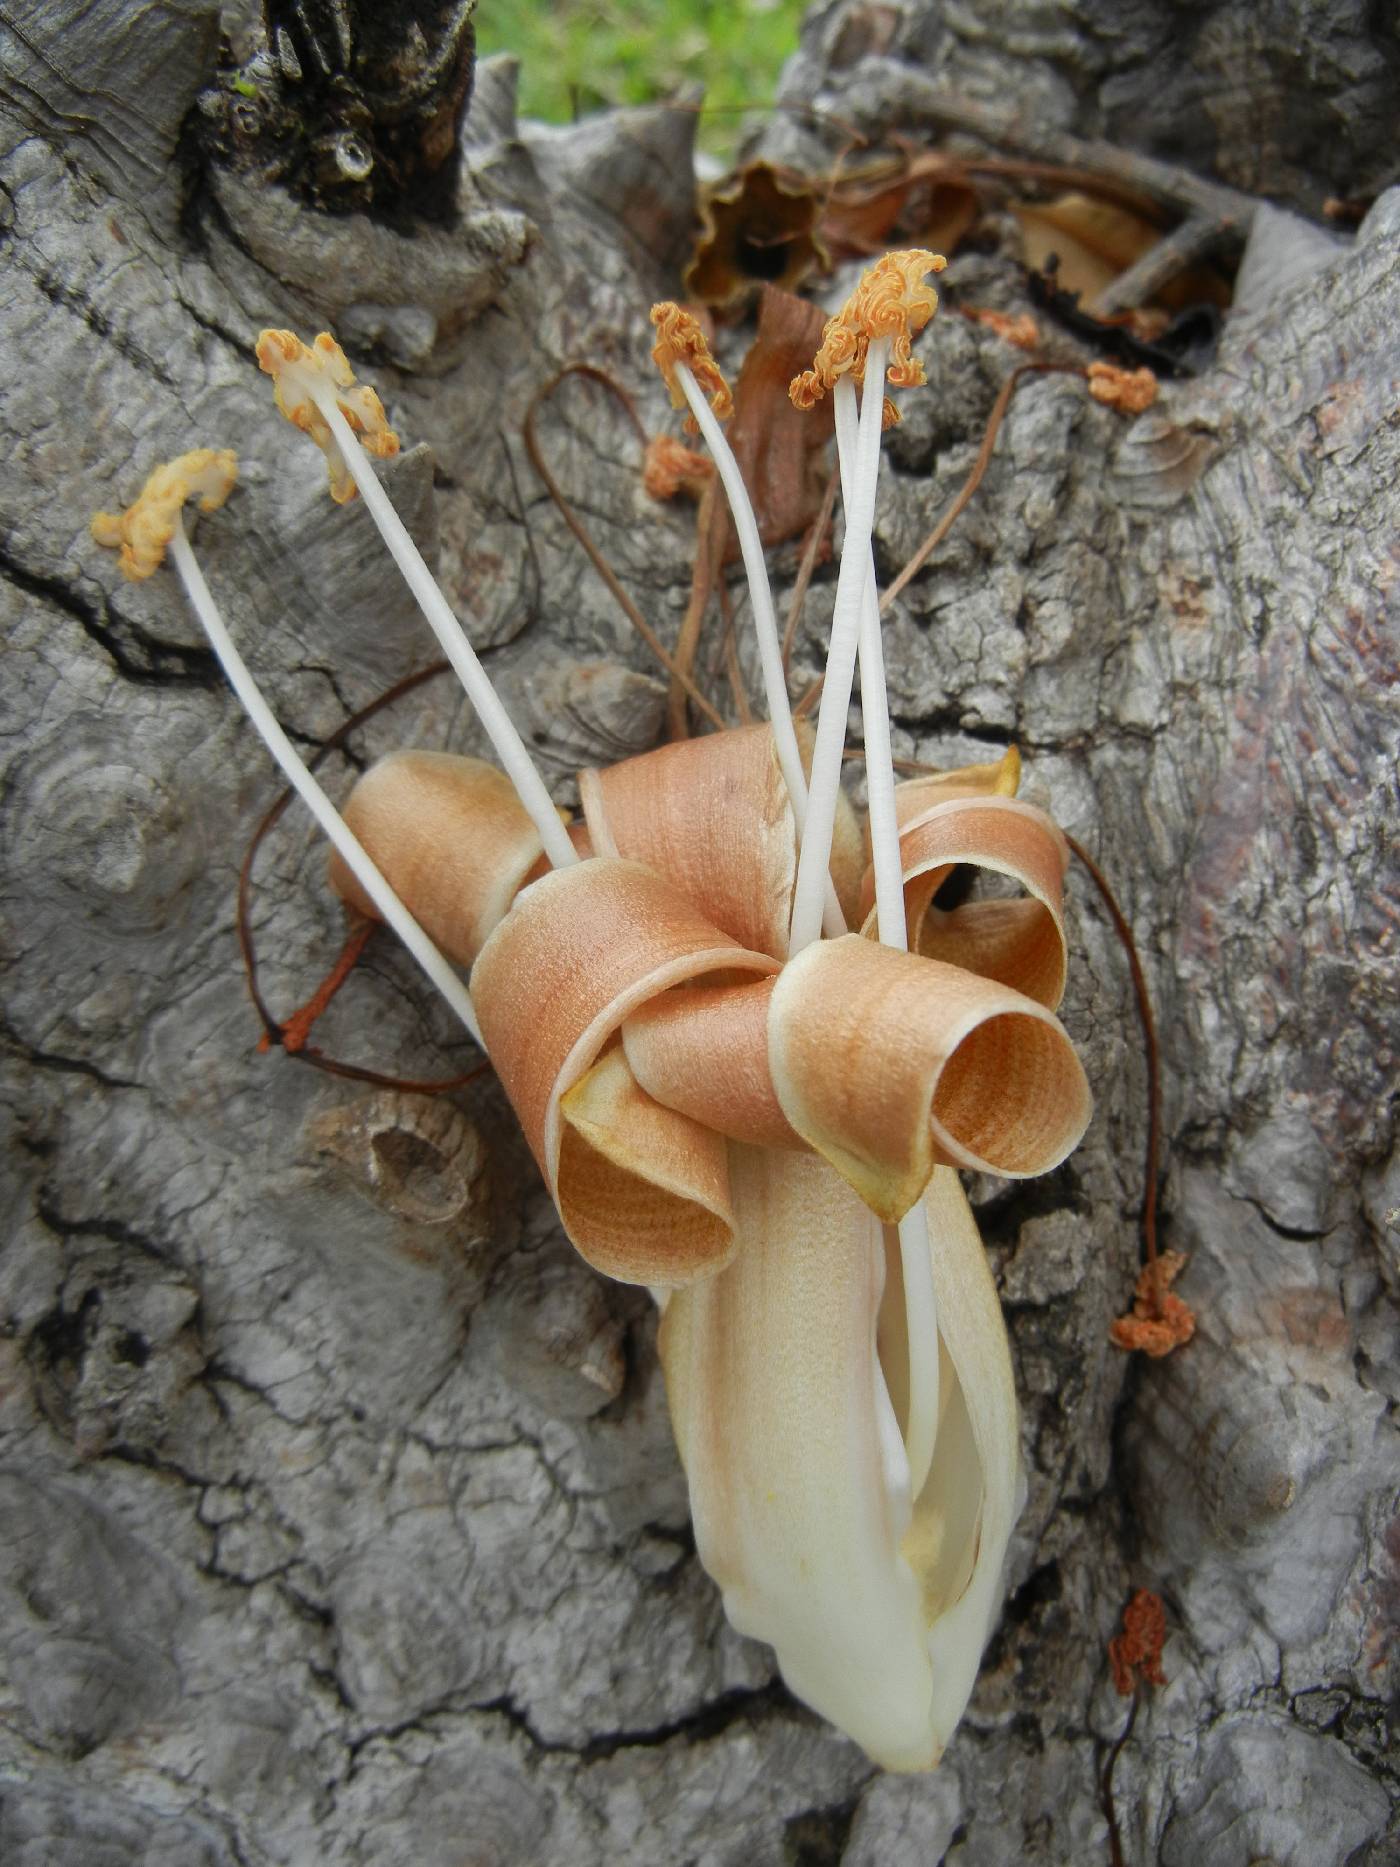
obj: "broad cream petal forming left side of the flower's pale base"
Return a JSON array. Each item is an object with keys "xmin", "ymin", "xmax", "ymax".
[{"xmin": 661, "ymin": 1146, "xmax": 943, "ymax": 1770}]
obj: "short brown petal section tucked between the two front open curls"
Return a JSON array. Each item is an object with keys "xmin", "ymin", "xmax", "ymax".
[{"xmin": 622, "ymin": 978, "xmax": 805, "ymax": 1148}]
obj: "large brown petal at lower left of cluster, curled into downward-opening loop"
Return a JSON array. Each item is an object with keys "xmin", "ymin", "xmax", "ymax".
[{"xmin": 472, "ymin": 855, "xmax": 777, "ymax": 1284}]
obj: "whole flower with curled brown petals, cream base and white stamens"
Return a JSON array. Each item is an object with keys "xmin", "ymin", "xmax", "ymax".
[{"xmin": 93, "ymin": 254, "xmax": 1090, "ymax": 1770}]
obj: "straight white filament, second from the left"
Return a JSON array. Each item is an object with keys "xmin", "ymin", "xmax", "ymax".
[{"xmin": 304, "ymin": 388, "xmax": 579, "ymax": 868}]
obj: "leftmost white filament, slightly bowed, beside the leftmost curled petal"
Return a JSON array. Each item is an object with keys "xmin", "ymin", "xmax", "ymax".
[{"xmin": 170, "ymin": 519, "xmax": 485, "ymax": 1044}]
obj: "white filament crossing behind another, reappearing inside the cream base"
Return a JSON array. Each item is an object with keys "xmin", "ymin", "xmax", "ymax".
[{"xmin": 833, "ymin": 375, "xmax": 939, "ymax": 1497}]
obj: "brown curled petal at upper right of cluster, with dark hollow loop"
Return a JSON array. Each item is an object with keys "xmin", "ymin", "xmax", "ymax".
[{"xmin": 864, "ymin": 797, "xmax": 1068, "ymax": 1010}]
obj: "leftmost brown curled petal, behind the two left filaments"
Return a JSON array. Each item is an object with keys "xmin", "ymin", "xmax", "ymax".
[{"xmin": 329, "ymin": 751, "xmax": 560, "ymax": 965}]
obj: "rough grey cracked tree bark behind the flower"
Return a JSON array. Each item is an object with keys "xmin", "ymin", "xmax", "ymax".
[{"xmin": 0, "ymin": 0, "xmax": 1400, "ymax": 1867}]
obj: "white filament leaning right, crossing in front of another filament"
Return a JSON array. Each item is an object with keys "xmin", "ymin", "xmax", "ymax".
[{"xmin": 790, "ymin": 338, "xmax": 890, "ymax": 954}]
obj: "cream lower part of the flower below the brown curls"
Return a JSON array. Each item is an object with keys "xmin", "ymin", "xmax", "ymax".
[{"xmin": 661, "ymin": 1148, "xmax": 1019, "ymax": 1770}]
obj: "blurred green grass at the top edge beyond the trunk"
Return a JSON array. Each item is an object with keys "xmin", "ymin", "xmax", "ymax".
[{"xmin": 476, "ymin": 0, "xmax": 805, "ymax": 155}]
